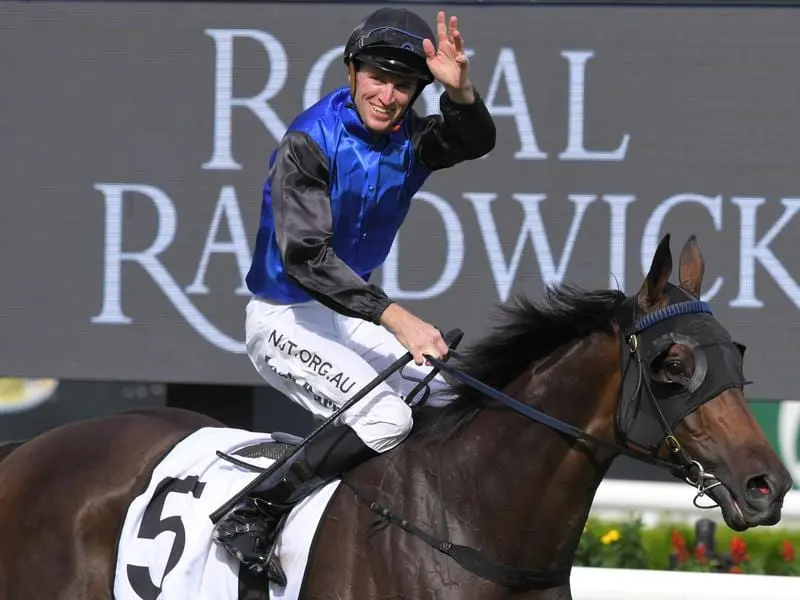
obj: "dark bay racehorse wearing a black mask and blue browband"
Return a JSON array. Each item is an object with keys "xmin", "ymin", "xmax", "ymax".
[{"xmin": 0, "ymin": 236, "xmax": 791, "ymax": 600}]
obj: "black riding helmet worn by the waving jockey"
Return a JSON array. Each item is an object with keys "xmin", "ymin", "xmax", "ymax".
[{"xmin": 344, "ymin": 7, "xmax": 436, "ymax": 86}]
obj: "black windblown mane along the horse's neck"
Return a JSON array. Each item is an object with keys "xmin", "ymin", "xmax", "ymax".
[{"xmin": 414, "ymin": 285, "xmax": 626, "ymax": 439}]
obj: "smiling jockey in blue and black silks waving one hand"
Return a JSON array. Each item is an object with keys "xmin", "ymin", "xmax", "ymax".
[{"xmin": 214, "ymin": 7, "xmax": 495, "ymax": 582}]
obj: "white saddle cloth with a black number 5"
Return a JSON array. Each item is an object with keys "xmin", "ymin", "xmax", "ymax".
[{"xmin": 114, "ymin": 428, "xmax": 339, "ymax": 600}]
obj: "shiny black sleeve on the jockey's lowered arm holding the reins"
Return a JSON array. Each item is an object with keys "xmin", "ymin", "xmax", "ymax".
[{"xmin": 270, "ymin": 132, "xmax": 391, "ymax": 324}]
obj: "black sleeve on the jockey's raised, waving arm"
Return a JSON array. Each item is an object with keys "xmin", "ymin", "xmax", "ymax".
[{"xmin": 411, "ymin": 90, "xmax": 497, "ymax": 170}]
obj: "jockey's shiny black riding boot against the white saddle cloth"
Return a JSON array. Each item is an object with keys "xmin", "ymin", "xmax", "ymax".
[{"xmin": 214, "ymin": 425, "xmax": 377, "ymax": 585}]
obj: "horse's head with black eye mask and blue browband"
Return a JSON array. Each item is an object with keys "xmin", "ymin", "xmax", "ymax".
[{"xmin": 617, "ymin": 235, "xmax": 791, "ymax": 531}]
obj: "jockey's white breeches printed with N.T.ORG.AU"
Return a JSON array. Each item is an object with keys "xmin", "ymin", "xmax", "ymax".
[{"xmin": 245, "ymin": 298, "xmax": 449, "ymax": 453}]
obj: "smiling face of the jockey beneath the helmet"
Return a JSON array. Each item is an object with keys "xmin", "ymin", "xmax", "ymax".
[{"xmin": 354, "ymin": 64, "xmax": 417, "ymax": 134}]
